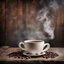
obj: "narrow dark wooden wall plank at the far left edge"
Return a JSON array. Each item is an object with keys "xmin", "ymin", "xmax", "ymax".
[{"xmin": 0, "ymin": 0, "xmax": 6, "ymax": 45}]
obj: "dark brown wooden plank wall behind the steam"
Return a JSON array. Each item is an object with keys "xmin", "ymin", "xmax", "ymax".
[{"xmin": 0, "ymin": 0, "xmax": 64, "ymax": 47}]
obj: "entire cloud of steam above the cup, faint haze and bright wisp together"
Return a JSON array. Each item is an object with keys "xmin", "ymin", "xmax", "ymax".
[{"xmin": 13, "ymin": 0, "xmax": 61, "ymax": 41}]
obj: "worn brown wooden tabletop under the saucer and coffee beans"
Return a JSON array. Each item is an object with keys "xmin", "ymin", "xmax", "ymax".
[{"xmin": 0, "ymin": 46, "xmax": 64, "ymax": 61}]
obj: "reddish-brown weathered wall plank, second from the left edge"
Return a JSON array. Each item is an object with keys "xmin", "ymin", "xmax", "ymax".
[{"xmin": 6, "ymin": 0, "xmax": 18, "ymax": 46}]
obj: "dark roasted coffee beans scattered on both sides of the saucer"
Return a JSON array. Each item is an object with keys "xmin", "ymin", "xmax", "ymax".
[{"xmin": 8, "ymin": 51, "xmax": 59, "ymax": 59}]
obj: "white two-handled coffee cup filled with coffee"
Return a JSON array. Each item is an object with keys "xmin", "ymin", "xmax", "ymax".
[{"xmin": 19, "ymin": 40, "xmax": 50, "ymax": 55}]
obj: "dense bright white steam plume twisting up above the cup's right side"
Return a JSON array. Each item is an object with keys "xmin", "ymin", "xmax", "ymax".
[{"xmin": 36, "ymin": 8, "xmax": 54, "ymax": 39}]
